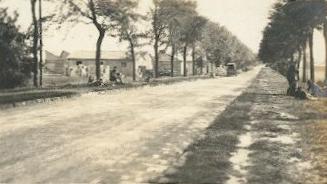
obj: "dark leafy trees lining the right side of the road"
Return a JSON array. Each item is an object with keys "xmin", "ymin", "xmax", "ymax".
[{"xmin": 259, "ymin": 0, "xmax": 327, "ymax": 82}]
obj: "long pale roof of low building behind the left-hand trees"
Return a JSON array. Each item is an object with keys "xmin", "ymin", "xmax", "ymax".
[{"xmin": 68, "ymin": 51, "xmax": 128, "ymax": 60}]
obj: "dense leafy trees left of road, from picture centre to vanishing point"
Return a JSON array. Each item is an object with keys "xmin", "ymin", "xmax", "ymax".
[{"xmin": 150, "ymin": 0, "xmax": 256, "ymax": 77}]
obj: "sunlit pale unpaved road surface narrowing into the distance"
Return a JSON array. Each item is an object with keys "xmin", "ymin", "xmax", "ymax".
[{"xmin": 0, "ymin": 67, "xmax": 261, "ymax": 184}]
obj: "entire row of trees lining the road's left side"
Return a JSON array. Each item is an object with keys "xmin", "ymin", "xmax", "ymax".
[{"xmin": 0, "ymin": 0, "xmax": 255, "ymax": 89}]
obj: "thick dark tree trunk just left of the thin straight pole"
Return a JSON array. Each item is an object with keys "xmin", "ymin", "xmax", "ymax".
[{"xmin": 31, "ymin": 0, "xmax": 39, "ymax": 87}]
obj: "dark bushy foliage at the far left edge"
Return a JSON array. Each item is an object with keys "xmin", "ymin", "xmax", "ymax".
[{"xmin": 0, "ymin": 8, "xmax": 30, "ymax": 88}]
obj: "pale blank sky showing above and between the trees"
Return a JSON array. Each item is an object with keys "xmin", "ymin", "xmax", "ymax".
[{"xmin": 1, "ymin": 0, "xmax": 323, "ymax": 60}]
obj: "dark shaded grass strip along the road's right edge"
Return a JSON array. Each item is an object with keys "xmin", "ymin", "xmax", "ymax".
[{"xmin": 148, "ymin": 92, "xmax": 251, "ymax": 184}]
